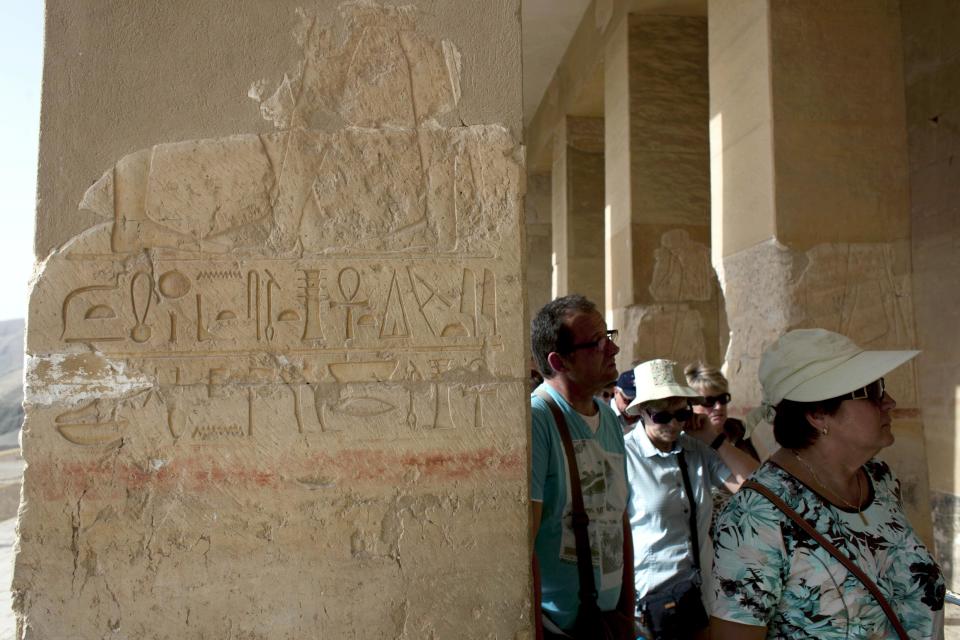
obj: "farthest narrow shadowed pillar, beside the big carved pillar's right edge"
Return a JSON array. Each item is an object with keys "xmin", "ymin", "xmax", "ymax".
[{"xmin": 523, "ymin": 173, "xmax": 553, "ymax": 318}]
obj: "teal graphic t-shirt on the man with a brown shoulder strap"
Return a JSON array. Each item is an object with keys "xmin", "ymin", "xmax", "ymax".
[{"xmin": 530, "ymin": 384, "xmax": 627, "ymax": 629}]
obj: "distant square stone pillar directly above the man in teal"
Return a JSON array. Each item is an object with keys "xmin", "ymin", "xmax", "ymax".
[{"xmin": 552, "ymin": 116, "xmax": 604, "ymax": 308}]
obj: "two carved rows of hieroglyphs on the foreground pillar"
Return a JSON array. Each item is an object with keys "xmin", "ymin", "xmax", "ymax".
[{"xmin": 47, "ymin": 257, "xmax": 510, "ymax": 445}]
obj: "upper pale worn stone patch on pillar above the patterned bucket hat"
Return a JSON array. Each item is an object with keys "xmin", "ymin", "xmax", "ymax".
[{"xmin": 650, "ymin": 229, "xmax": 714, "ymax": 302}]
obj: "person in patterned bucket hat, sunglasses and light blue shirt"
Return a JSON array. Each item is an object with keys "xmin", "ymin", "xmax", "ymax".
[{"xmin": 624, "ymin": 359, "xmax": 757, "ymax": 640}]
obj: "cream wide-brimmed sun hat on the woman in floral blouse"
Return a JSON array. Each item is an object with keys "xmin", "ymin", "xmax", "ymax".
[{"xmin": 746, "ymin": 329, "xmax": 920, "ymax": 431}]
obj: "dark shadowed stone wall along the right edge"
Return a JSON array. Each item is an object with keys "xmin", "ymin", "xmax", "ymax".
[{"xmin": 900, "ymin": 0, "xmax": 960, "ymax": 591}]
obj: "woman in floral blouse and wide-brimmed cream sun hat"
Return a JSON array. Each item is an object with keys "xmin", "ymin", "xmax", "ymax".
[{"xmin": 711, "ymin": 329, "xmax": 945, "ymax": 640}]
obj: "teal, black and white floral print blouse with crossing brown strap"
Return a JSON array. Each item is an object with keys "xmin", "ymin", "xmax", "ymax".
[{"xmin": 713, "ymin": 460, "xmax": 945, "ymax": 640}]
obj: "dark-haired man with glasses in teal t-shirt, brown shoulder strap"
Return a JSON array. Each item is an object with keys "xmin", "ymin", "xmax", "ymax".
[{"xmin": 530, "ymin": 295, "xmax": 635, "ymax": 640}]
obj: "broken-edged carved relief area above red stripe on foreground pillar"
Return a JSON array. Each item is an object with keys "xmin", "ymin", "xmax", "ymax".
[{"xmin": 27, "ymin": 3, "xmax": 522, "ymax": 447}]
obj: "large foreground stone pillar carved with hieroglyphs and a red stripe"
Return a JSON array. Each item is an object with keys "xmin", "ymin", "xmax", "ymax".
[{"xmin": 22, "ymin": 0, "xmax": 531, "ymax": 638}]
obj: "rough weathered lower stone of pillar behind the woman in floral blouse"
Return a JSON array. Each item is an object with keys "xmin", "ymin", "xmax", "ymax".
[{"xmin": 721, "ymin": 241, "xmax": 931, "ymax": 541}]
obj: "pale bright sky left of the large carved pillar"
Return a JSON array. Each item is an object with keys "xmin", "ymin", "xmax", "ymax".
[{"xmin": 0, "ymin": 0, "xmax": 43, "ymax": 320}]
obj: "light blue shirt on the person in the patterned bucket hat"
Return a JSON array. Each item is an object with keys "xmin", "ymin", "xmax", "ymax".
[{"xmin": 624, "ymin": 423, "xmax": 730, "ymax": 598}]
